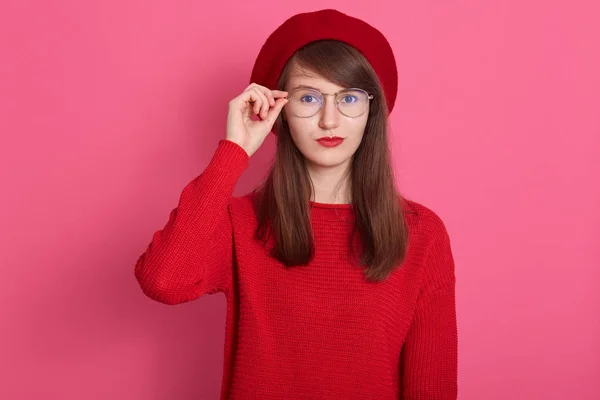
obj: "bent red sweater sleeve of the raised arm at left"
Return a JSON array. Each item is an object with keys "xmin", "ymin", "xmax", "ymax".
[{"xmin": 135, "ymin": 140, "xmax": 249, "ymax": 304}]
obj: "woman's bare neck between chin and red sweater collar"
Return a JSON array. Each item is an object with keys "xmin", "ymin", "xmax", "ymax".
[{"xmin": 307, "ymin": 159, "xmax": 351, "ymax": 204}]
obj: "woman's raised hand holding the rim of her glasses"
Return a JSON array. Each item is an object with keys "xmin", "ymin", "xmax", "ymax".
[{"xmin": 226, "ymin": 83, "xmax": 289, "ymax": 156}]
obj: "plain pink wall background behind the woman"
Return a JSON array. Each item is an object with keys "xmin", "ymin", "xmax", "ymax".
[{"xmin": 0, "ymin": 0, "xmax": 600, "ymax": 400}]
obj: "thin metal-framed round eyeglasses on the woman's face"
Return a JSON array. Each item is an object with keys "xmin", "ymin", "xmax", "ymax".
[{"xmin": 287, "ymin": 88, "xmax": 373, "ymax": 118}]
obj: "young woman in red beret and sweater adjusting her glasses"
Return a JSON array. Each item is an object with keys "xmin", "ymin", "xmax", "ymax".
[{"xmin": 135, "ymin": 10, "xmax": 457, "ymax": 400}]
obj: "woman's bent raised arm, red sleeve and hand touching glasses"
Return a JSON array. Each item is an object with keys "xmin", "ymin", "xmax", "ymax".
[{"xmin": 135, "ymin": 84, "xmax": 287, "ymax": 304}]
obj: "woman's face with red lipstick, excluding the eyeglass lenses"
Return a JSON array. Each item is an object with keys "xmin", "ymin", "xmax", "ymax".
[{"xmin": 283, "ymin": 68, "xmax": 369, "ymax": 172}]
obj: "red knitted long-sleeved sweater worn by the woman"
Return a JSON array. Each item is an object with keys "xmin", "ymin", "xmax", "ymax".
[{"xmin": 135, "ymin": 140, "xmax": 458, "ymax": 400}]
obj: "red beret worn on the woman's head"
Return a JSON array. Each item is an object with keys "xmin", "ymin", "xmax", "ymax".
[{"xmin": 250, "ymin": 9, "xmax": 398, "ymax": 112}]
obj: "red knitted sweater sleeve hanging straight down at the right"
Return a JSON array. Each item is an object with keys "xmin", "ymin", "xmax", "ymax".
[{"xmin": 400, "ymin": 214, "xmax": 458, "ymax": 400}]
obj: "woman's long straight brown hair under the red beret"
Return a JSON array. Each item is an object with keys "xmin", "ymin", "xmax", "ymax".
[{"xmin": 254, "ymin": 40, "xmax": 408, "ymax": 282}]
